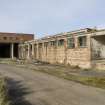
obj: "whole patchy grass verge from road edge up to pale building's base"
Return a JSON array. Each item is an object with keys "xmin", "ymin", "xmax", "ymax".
[{"xmin": 0, "ymin": 61, "xmax": 105, "ymax": 89}]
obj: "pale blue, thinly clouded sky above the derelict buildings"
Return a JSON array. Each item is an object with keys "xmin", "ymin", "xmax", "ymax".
[{"xmin": 0, "ymin": 0, "xmax": 105, "ymax": 37}]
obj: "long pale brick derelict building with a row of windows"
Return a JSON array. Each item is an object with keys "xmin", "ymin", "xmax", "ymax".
[{"xmin": 19, "ymin": 28, "xmax": 105, "ymax": 69}]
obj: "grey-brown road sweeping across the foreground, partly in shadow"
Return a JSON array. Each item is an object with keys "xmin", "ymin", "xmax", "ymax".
[{"xmin": 0, "ymin": 64, "xmax": 105, "ymax": 105}]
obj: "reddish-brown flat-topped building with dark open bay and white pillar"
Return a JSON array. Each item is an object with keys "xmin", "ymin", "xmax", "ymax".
[{"xmin": 0, "ymin": 32, "xmax": 34, "ymax": 59}]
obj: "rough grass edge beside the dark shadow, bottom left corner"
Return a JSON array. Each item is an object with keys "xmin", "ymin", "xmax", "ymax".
[{"xmin": 0, "ymin": 77, "xmax": 10, "ymax": 105}]
